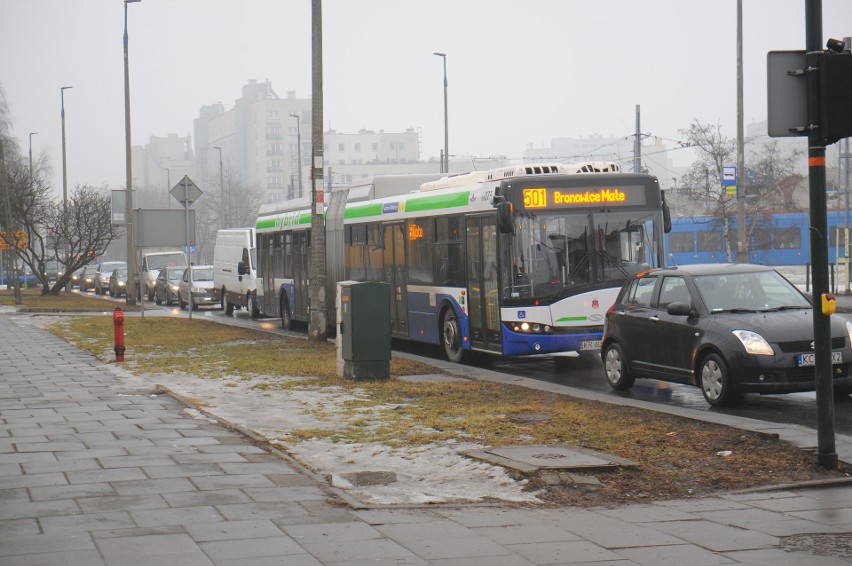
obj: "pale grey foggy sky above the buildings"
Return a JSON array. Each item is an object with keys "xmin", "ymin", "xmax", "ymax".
[{"xmin": 0, "ymin": 0, "xmax": 852, "ymax": 196}]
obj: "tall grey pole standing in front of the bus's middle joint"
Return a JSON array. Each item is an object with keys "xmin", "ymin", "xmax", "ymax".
[{"xmin": 308, "ymin": 0, "xmax": 328, "ymax": 342}]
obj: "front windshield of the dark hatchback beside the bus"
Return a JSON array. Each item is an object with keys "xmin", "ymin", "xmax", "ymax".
[{"xmin": 695, "ymin": 271, "xmax": 811, "ymax": 312}]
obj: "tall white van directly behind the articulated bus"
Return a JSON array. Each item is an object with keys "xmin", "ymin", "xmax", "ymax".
[{"xmin": 213, "ymin": 228, "xmax": 259, "ymax": 318}]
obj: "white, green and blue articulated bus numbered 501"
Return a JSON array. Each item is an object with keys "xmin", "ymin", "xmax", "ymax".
[{"xmin": 256, "ymin": 163, "xmax": 670, "ymax": 361}]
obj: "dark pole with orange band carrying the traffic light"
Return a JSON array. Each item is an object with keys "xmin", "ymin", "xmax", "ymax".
[{"xmin": 805, "ymin": 0, "xmax": 837, "ymax": 470}]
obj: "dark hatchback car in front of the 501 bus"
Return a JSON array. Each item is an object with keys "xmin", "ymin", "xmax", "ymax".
[{"xmin": 601, "ymin": 264, "xmax": 852, "ymax": 406}]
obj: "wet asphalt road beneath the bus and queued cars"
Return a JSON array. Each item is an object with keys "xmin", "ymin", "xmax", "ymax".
[{"xmin": 76, "ymin": 292, "xmax": 852, "ymax": 440}]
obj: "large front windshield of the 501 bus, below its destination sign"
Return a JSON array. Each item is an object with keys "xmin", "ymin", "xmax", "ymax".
[{"xmin": 503, "ymin": 210, "xmax": 658, "ymax": 300}]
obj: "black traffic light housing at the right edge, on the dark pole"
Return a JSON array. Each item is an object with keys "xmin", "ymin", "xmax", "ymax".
[{"xmin": 819, "ymin": 46, "xmax": 852, "ymax": 145}]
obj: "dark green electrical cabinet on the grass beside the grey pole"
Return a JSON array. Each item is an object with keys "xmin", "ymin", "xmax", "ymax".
[{"xmin": 340, "ymin": 281, "xmax": 391, "ymax": 380}]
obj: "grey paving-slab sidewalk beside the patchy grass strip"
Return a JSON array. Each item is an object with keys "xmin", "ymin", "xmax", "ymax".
[{"xmin": 0, "ymin": 314, "xmax": 852, "ymax": 566}]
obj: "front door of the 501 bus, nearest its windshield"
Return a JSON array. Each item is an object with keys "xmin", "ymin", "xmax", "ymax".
[{"xmin": 467, "ymin": 215, "xmax": 502, "ymax": 352}]
